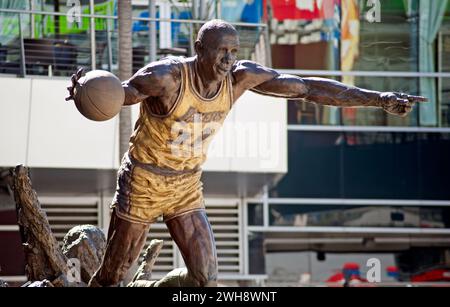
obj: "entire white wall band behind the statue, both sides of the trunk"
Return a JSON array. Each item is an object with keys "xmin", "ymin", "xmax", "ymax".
[{"xmin": 0, "ymin": 77, "xmax": 287, "ymax": 173}]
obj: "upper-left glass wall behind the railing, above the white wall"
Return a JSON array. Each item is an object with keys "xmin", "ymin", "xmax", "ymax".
[{"xmin": 0, "ymin": 0, "xmax": 268, "ymax": 77}]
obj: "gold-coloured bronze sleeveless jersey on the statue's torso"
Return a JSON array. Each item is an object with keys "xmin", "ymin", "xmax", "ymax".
[{"xmin": 129, "ymin": 62, "xmax": 232, "ymax": 171}]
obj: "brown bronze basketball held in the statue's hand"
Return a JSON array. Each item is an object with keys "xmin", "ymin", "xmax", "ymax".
[{"xmin": 74, "ymin": 70, "xmax": 125, "ymax": 121}]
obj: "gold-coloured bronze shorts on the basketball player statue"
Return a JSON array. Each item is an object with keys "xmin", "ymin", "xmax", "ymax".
[{"xmin": 111, "ymin": 153, "xmax": 205, "ymax": 224}]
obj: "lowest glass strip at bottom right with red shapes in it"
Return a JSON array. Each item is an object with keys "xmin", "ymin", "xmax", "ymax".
[{"xmin": 265, "ymin": 248, "xmax": 449, "ymax": 287}]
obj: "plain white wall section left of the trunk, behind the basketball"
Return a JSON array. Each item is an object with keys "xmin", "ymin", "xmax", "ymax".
[{"xmin": 0, "ymin": 78, "xmax": 118, "ymax": 169}]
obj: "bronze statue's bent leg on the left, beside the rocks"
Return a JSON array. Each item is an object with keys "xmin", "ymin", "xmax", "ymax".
[{"xmin": 89, "ymin": 209, "xmax": 150, "ymax": 287}]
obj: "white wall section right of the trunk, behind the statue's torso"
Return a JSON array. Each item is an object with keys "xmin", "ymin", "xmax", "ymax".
[{"xmin": 132, "ymin": 91, "xmax": 287, "ymax": 173}]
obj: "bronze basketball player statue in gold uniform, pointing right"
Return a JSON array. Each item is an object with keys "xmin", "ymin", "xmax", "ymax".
[{"xmin": 65, "ymin": 20, "xmax": 426, "ymax": 286}]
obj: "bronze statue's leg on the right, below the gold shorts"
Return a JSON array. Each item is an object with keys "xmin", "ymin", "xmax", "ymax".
[{"xmin": 153, "ymin": 210, "xmax": 217, "ymax": 287}]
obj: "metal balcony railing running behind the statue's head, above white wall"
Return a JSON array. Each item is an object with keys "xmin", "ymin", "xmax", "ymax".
[{"xmin": 0, "ymin": 9, "xmax": 270, "ymax": 76}]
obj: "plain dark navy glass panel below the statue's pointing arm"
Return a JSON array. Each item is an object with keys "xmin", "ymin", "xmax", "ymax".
[{"xmin": 270, "ymin": 131, "xmax": 450, "ymax": 200}]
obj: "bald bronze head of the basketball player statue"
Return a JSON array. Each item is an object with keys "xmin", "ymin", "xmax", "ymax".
[{"xmin": 195, "ymin": 19, "xmax": 239, "ymax": 80}]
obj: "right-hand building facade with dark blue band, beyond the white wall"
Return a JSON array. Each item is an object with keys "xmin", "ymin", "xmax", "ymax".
[{"xmin": 258, "ymin": 0, "xmax": 450, "ymax": 285}]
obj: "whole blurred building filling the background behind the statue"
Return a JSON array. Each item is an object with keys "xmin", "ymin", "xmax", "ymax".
[{"xmin": 0, "ymin": 0, "xmax": 450, "ymax": 286}]
